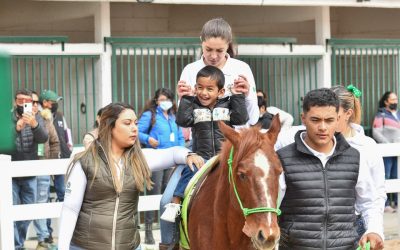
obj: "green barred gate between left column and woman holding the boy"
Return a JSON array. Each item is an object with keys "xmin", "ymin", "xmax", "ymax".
[{"xmin": 105, "ymin": 37, "xmax": 200, "ymax": 112}]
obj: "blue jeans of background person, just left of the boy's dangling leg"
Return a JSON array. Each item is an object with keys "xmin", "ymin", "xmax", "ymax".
[{"xmin": 160, "ymin": 165, "xmax": 186, "ymax": 245}]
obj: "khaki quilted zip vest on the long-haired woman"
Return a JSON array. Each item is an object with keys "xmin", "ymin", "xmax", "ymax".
[{"xmin": 71, "ymin": 144, "xmax": 140, "ymax": 250}]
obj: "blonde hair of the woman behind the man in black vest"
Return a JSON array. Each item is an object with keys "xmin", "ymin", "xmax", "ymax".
[{"xmin": 331, "ymin": 85, "xmax": 362, "ymax": 124}]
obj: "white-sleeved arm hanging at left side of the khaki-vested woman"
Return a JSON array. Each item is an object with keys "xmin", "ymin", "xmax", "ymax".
[{"xmin": 58, "ymin": 161, "xmax": 87, "ymax": 250}]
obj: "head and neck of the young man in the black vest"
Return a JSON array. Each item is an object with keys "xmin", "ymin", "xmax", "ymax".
[{"xmin": 301, "ymin": 106, "xmax": 338, "ymax": 153}]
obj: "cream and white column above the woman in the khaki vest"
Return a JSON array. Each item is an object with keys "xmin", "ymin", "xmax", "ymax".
[{"xmin": 94, "ymin": 2, "xmax": 112, "ymax": 107}]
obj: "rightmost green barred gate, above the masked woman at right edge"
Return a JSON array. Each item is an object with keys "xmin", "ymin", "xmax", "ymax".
[{"xmin": 328, "ymin": 39, "xmax": 400, "ymax": 133}]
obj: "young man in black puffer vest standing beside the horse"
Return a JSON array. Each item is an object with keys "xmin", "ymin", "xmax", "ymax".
[{"xmin": 277, "ymin": 89, "xmax": 383, "ymax": 250}]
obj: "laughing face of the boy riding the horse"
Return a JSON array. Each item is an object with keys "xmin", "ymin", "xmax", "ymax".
[{"xmin": 195, "ymin": 77, "xmax": 225, "ymax": 108}]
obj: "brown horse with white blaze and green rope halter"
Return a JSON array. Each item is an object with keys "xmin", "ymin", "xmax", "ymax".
[{"xmin": 188, "ymin": 115, "xmax": 282, "ymax": 250}]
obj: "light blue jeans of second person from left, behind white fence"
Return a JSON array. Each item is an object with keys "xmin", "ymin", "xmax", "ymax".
[{"xmin": 33, "ymin": 175, "xmax": 50, "ymax": 241}]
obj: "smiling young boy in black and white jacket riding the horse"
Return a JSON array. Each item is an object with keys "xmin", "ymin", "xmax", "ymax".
[{"xmin": 161, "ymin": 66, "xmax": 249, "ymax": 222}]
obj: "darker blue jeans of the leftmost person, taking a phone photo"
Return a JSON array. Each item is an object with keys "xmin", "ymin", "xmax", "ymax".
[{"xmin": 12, "ymin": 177, "xmax": 37, "ymax": 249}]
